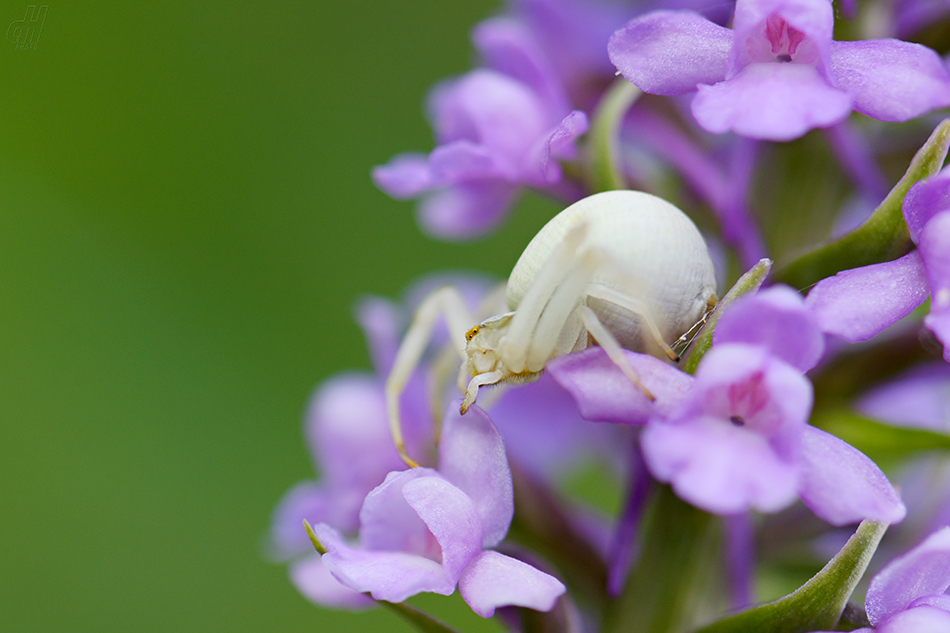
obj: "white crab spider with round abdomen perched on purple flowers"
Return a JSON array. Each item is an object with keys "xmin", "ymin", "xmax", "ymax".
[{"xmin": 386, "ymin": 191, "xmax": 717, "ymax": 466}]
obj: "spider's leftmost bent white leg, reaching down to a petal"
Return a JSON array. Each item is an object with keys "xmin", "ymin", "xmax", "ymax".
[{"xmin": 386, "ymin": 287, "xmax": 473, "ymax": 468}]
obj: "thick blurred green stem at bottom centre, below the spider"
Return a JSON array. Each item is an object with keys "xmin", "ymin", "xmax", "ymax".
[{"xmin": 602, "ymin": 485, "xmax": 721, "ymax": 633}]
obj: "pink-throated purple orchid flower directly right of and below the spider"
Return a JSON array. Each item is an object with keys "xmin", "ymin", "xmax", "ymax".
[{"xmin": 549, "ymin": 287, "xmax": 906, "ymax": 525}]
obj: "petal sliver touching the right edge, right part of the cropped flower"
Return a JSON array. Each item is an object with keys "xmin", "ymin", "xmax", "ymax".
[{"xmin": 919, "ymin": 211, "xmax": 950, "ymax": 360}]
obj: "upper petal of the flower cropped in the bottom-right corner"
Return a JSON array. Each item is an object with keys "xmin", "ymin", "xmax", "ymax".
[{"xmin": 865, "ymin": 527, "xmax": 950, "ymax": 630}]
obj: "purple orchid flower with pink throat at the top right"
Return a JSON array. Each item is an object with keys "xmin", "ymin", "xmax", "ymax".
[{"xmin": 608, "ymin": 0, "xmax": 950, "ymax": 141}]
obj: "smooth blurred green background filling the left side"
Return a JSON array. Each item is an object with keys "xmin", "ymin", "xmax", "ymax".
[{"xmin": 0, "ymin": 0, "xmax": 572, "ymax": 633}]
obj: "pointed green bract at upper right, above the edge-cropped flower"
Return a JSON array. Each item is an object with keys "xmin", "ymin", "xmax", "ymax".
[{"xmin": 775, "ymin": 119, "xmax": 950, "ymax": 289}]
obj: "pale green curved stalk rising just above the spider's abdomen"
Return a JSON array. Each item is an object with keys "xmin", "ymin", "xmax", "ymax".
[{"xmin": 588, "ymin": 77, "xmax": 642, "ymax": 193}]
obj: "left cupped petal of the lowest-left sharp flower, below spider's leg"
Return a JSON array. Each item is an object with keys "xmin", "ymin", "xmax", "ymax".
[{"xmin": 360, "ymin": 468, "xmax": 441, "ymax": 558}]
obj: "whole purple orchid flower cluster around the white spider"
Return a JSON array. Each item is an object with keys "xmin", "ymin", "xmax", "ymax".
[{"xmin": 271, "ymin": 0, "xmax": 950, "ymax": 633}]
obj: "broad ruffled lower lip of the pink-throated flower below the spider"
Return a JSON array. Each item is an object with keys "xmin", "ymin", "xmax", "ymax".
[{"xmin": 640, "ymin": 417, "xmax": 799, "ymax": 514}]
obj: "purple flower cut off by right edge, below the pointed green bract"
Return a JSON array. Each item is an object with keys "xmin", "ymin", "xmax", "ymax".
[{"xmin": 806, "ymin": 169, "xmax": 950, "ymax": 361}]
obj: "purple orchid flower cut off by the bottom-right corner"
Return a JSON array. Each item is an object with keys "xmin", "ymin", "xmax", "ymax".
[{"xmin": 812, "ymin": 527, "xmax": 950, "ymax": 633}]
